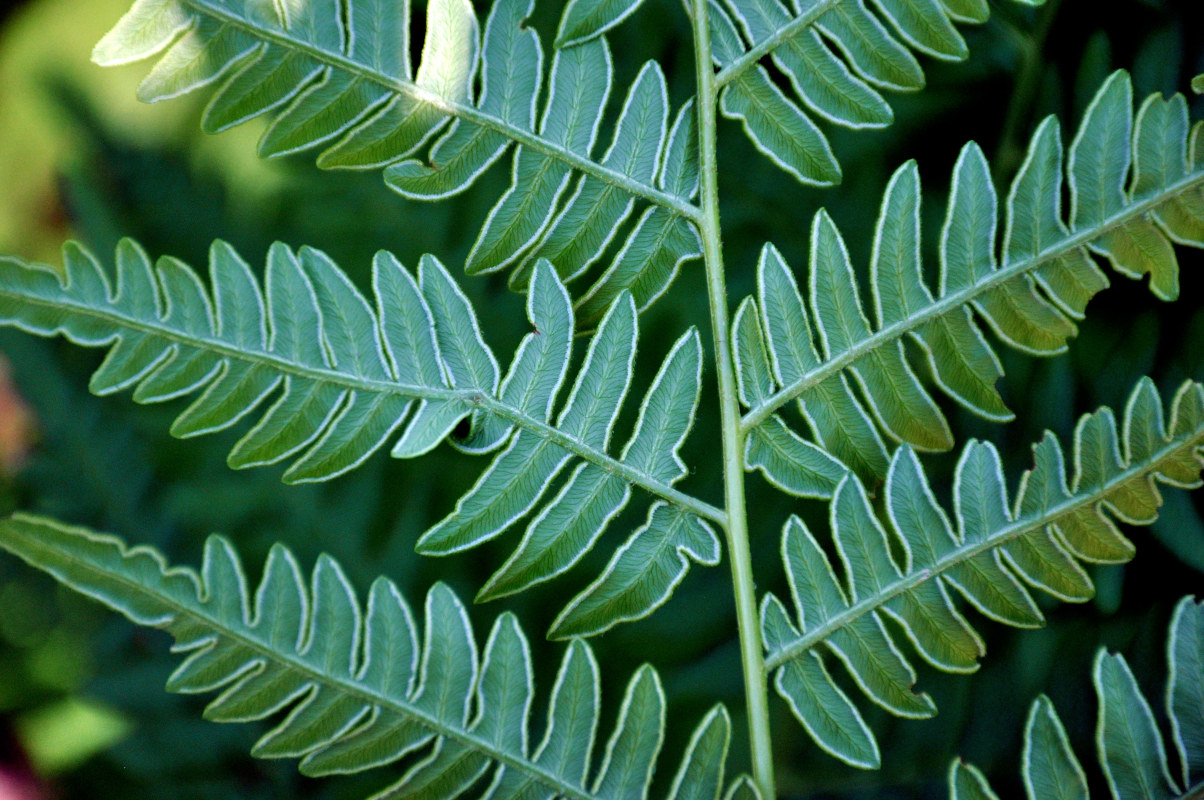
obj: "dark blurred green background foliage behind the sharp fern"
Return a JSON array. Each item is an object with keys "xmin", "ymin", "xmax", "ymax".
[{"xmin": 0, "ymin": 0, "xmax": 1204, "ymax": 800}]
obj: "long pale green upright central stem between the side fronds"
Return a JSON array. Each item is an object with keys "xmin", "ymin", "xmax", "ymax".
[{"xmin": 691, "ymin": 0, "xmax": 777, "ymax": 800}]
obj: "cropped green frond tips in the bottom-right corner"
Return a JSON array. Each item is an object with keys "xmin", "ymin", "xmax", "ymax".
[{"xmin": 949, "ymin": 598, "xmax": 1204, "ymax": 800}]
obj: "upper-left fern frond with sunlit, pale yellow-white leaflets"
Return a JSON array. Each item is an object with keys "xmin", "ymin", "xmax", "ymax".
[{"xmin": 101, "ymin": 0, "xmax": 701, "ymax": 313}]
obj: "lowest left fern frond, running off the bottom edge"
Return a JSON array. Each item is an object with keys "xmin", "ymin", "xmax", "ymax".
[{"xmin": 0, "ymin": 514, "xmax": 731, "ymax": 800}]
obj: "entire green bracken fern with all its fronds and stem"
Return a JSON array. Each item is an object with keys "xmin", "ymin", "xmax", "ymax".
[{"xmin": 0, "ymin": 0, "xmax": 1204, "ymax": 800}]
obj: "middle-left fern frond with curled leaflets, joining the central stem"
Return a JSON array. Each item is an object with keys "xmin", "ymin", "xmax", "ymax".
[{"xmin": 0, "ymin": 240, "xmax": 725, "ymax": 635}]
